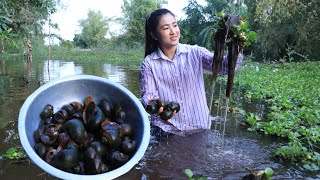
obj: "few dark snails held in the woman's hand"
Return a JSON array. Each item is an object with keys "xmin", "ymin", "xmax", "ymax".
[{"xmin": 145, "ymin": 99, "xmax": 180, "ymax": 121}]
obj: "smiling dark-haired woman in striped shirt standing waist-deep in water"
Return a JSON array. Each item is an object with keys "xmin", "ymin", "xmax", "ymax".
[{"xmin": 139, "ymin": 9, "xmax": 243, "ymax": 136}]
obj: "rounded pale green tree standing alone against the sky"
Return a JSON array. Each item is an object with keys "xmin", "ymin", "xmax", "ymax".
[{"xmin": 73, "ymin": 10, "xmax": 109, "ymax": 48}]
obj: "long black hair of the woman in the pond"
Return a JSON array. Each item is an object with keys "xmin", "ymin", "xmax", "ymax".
[{"xmin": 144, "ymin": 8, "xmax": 175, "ymax": 57}]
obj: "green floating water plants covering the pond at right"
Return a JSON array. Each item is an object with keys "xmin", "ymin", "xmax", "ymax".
[{"xmin": 237, "ymin": 62, "xmax": 320, "ymax": 170}]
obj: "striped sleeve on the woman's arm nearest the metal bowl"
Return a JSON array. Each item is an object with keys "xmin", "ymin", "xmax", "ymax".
[{"xmin": 139, "ymin": 61, "xmax": 159, "ymax": 106}]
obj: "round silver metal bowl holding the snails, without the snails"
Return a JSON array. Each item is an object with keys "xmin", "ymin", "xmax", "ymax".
[{"xmin": 18, "ymin": 75, "xmax": 150, "ymax": 179}]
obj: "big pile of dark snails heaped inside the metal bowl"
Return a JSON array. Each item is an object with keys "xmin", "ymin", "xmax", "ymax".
[{"xmin": 34, "ymin": 96, "xmax": 136, "ymax": 175}]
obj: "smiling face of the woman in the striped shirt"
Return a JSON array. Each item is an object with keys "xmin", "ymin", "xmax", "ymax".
[{"xmin": 155, "ymin": 13, "xmax": 180, "ymax": 48}]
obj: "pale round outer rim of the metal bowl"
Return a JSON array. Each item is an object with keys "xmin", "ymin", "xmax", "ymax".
[{"xmin": 18, "ymin": 75, "xmax": 150, "ymax": 179}]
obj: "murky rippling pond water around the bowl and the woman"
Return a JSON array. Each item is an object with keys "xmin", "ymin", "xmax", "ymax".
[{"xmin": 0, "ymin": 60, "xmax": 320, "ymax": 179}]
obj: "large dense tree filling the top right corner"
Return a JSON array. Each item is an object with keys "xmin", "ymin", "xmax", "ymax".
[{"xmin": 245, "ymin": 0, "xmax": 320, "ymax": 60}]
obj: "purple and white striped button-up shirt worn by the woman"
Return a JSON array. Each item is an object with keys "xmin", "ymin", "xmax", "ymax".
[{"xmin": 139, "ymin": 44, "xmax": 242, "ymax": 134}]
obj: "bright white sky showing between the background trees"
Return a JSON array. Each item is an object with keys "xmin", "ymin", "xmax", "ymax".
[{"xmin": 48, "ymin": 0, "xmax": 205, "ymax": 41}]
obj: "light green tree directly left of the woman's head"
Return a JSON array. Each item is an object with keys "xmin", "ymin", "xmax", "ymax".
[{"xmin": 121, "ymin": 0, "xmax": 167, "ymax": 46}]
